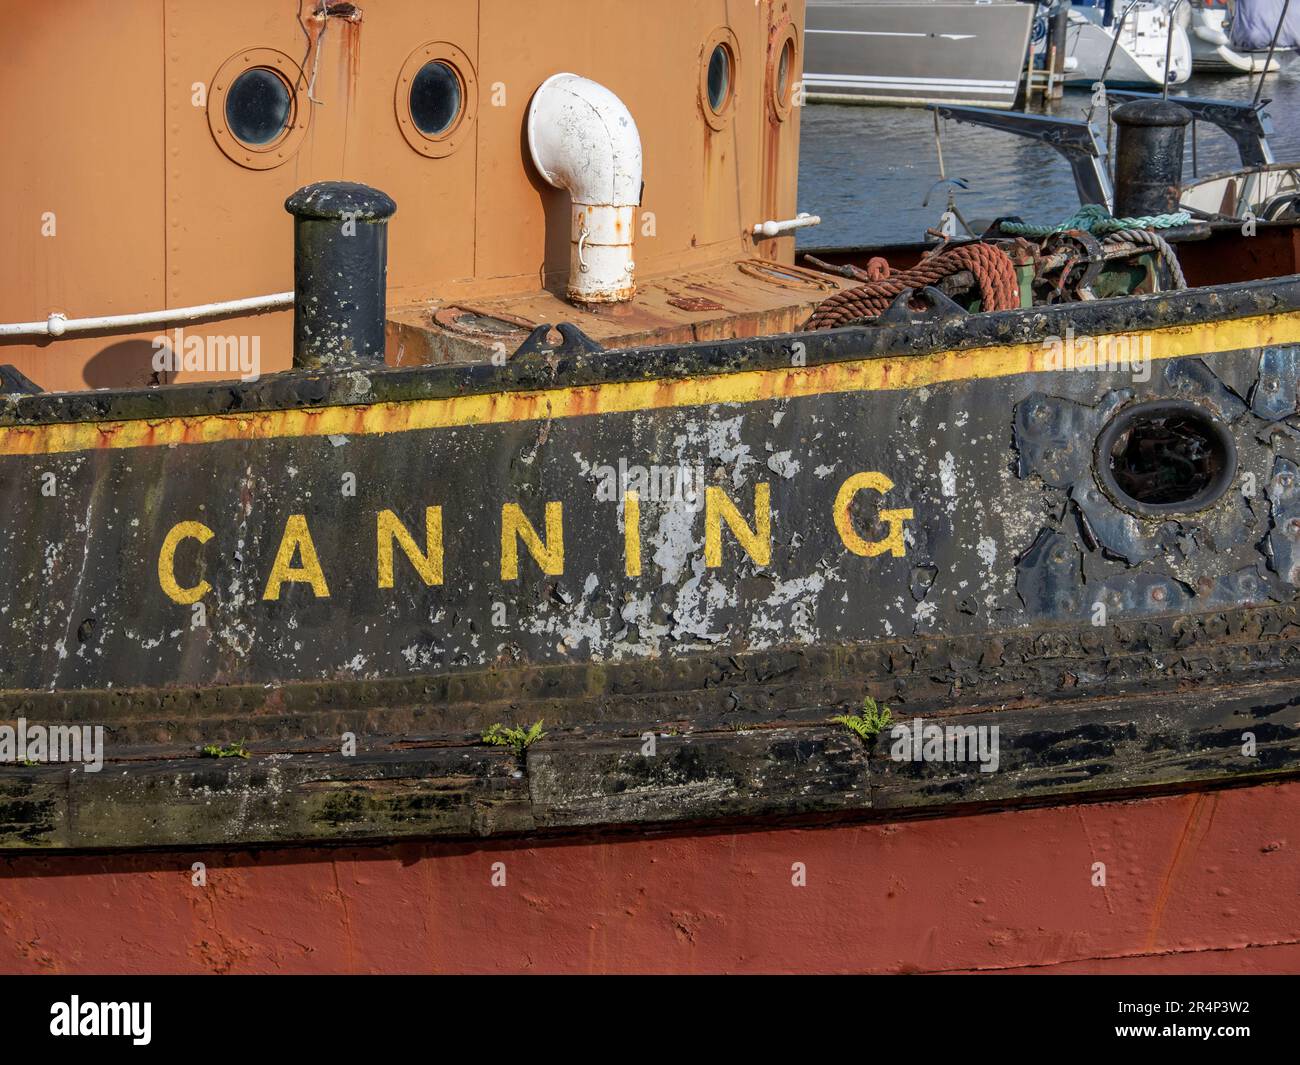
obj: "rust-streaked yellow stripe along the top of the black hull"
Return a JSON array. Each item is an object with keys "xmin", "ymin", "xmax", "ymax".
[{"xmin": 0, "ymin": 313, "xmax": 1300, "ymax": 455}]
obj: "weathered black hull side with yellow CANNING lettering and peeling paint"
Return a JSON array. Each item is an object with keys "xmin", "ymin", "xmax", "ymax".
[{"xmin": 0, "ymin": 280, "xmax": 1300, "ymax": 848}]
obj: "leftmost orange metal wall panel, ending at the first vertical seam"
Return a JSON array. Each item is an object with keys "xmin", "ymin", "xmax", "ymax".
[{"xmin": 0, "ymin": 0, "xmax": 168, "ymax": 388}]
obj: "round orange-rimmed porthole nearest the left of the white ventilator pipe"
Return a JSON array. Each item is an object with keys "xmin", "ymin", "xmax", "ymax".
[{"xmin": 394, "ymin": 40, "xmax": 478, "ymax": 159}]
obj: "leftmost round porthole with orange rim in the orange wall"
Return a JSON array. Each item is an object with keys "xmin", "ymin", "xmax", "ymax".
[{"xmin": 208, "ymin": 48, "xmax": 311, "ymax": 170}]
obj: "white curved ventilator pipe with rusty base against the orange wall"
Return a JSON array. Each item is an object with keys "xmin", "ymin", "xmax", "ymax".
[{"xmin": 528, "ymin": 74, "xmax": 641, "ymax": 303}]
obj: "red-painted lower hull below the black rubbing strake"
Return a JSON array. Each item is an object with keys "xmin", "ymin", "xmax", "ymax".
[{"xmin": 0, "ymin": 783, "xmax": 1300, "ymax": 973}]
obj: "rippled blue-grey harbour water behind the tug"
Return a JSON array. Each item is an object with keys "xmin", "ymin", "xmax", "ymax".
[{"xmin": 798, "ymin": 67, "xmax": 1300, "ymax": 248}]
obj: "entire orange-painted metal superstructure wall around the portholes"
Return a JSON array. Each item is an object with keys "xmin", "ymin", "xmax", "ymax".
[{"xmin": 0, "ymin": 0, "xmax": 803, "ymax": 389}]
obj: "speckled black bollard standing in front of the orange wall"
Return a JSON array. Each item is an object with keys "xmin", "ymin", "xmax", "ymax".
[{"xmin": 285, "ymin": 181, "xmax": 398, "ymax": 369}]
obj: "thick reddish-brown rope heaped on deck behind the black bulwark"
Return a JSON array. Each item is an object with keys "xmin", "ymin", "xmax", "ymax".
[{"xmin": 803, "ymin": 244, "xmax": 1021, "ymax": 329}]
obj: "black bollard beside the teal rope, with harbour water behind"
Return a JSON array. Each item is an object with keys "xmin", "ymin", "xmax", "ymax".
[{"xmin": 1110, "ymin": 100, "xmax": 1192, "ymax": 218}]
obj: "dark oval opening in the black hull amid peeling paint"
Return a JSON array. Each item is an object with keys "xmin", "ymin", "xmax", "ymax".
[{"xmin": 1095, "ymin": 399, "xmax": 1236, "ymax": 515}]
